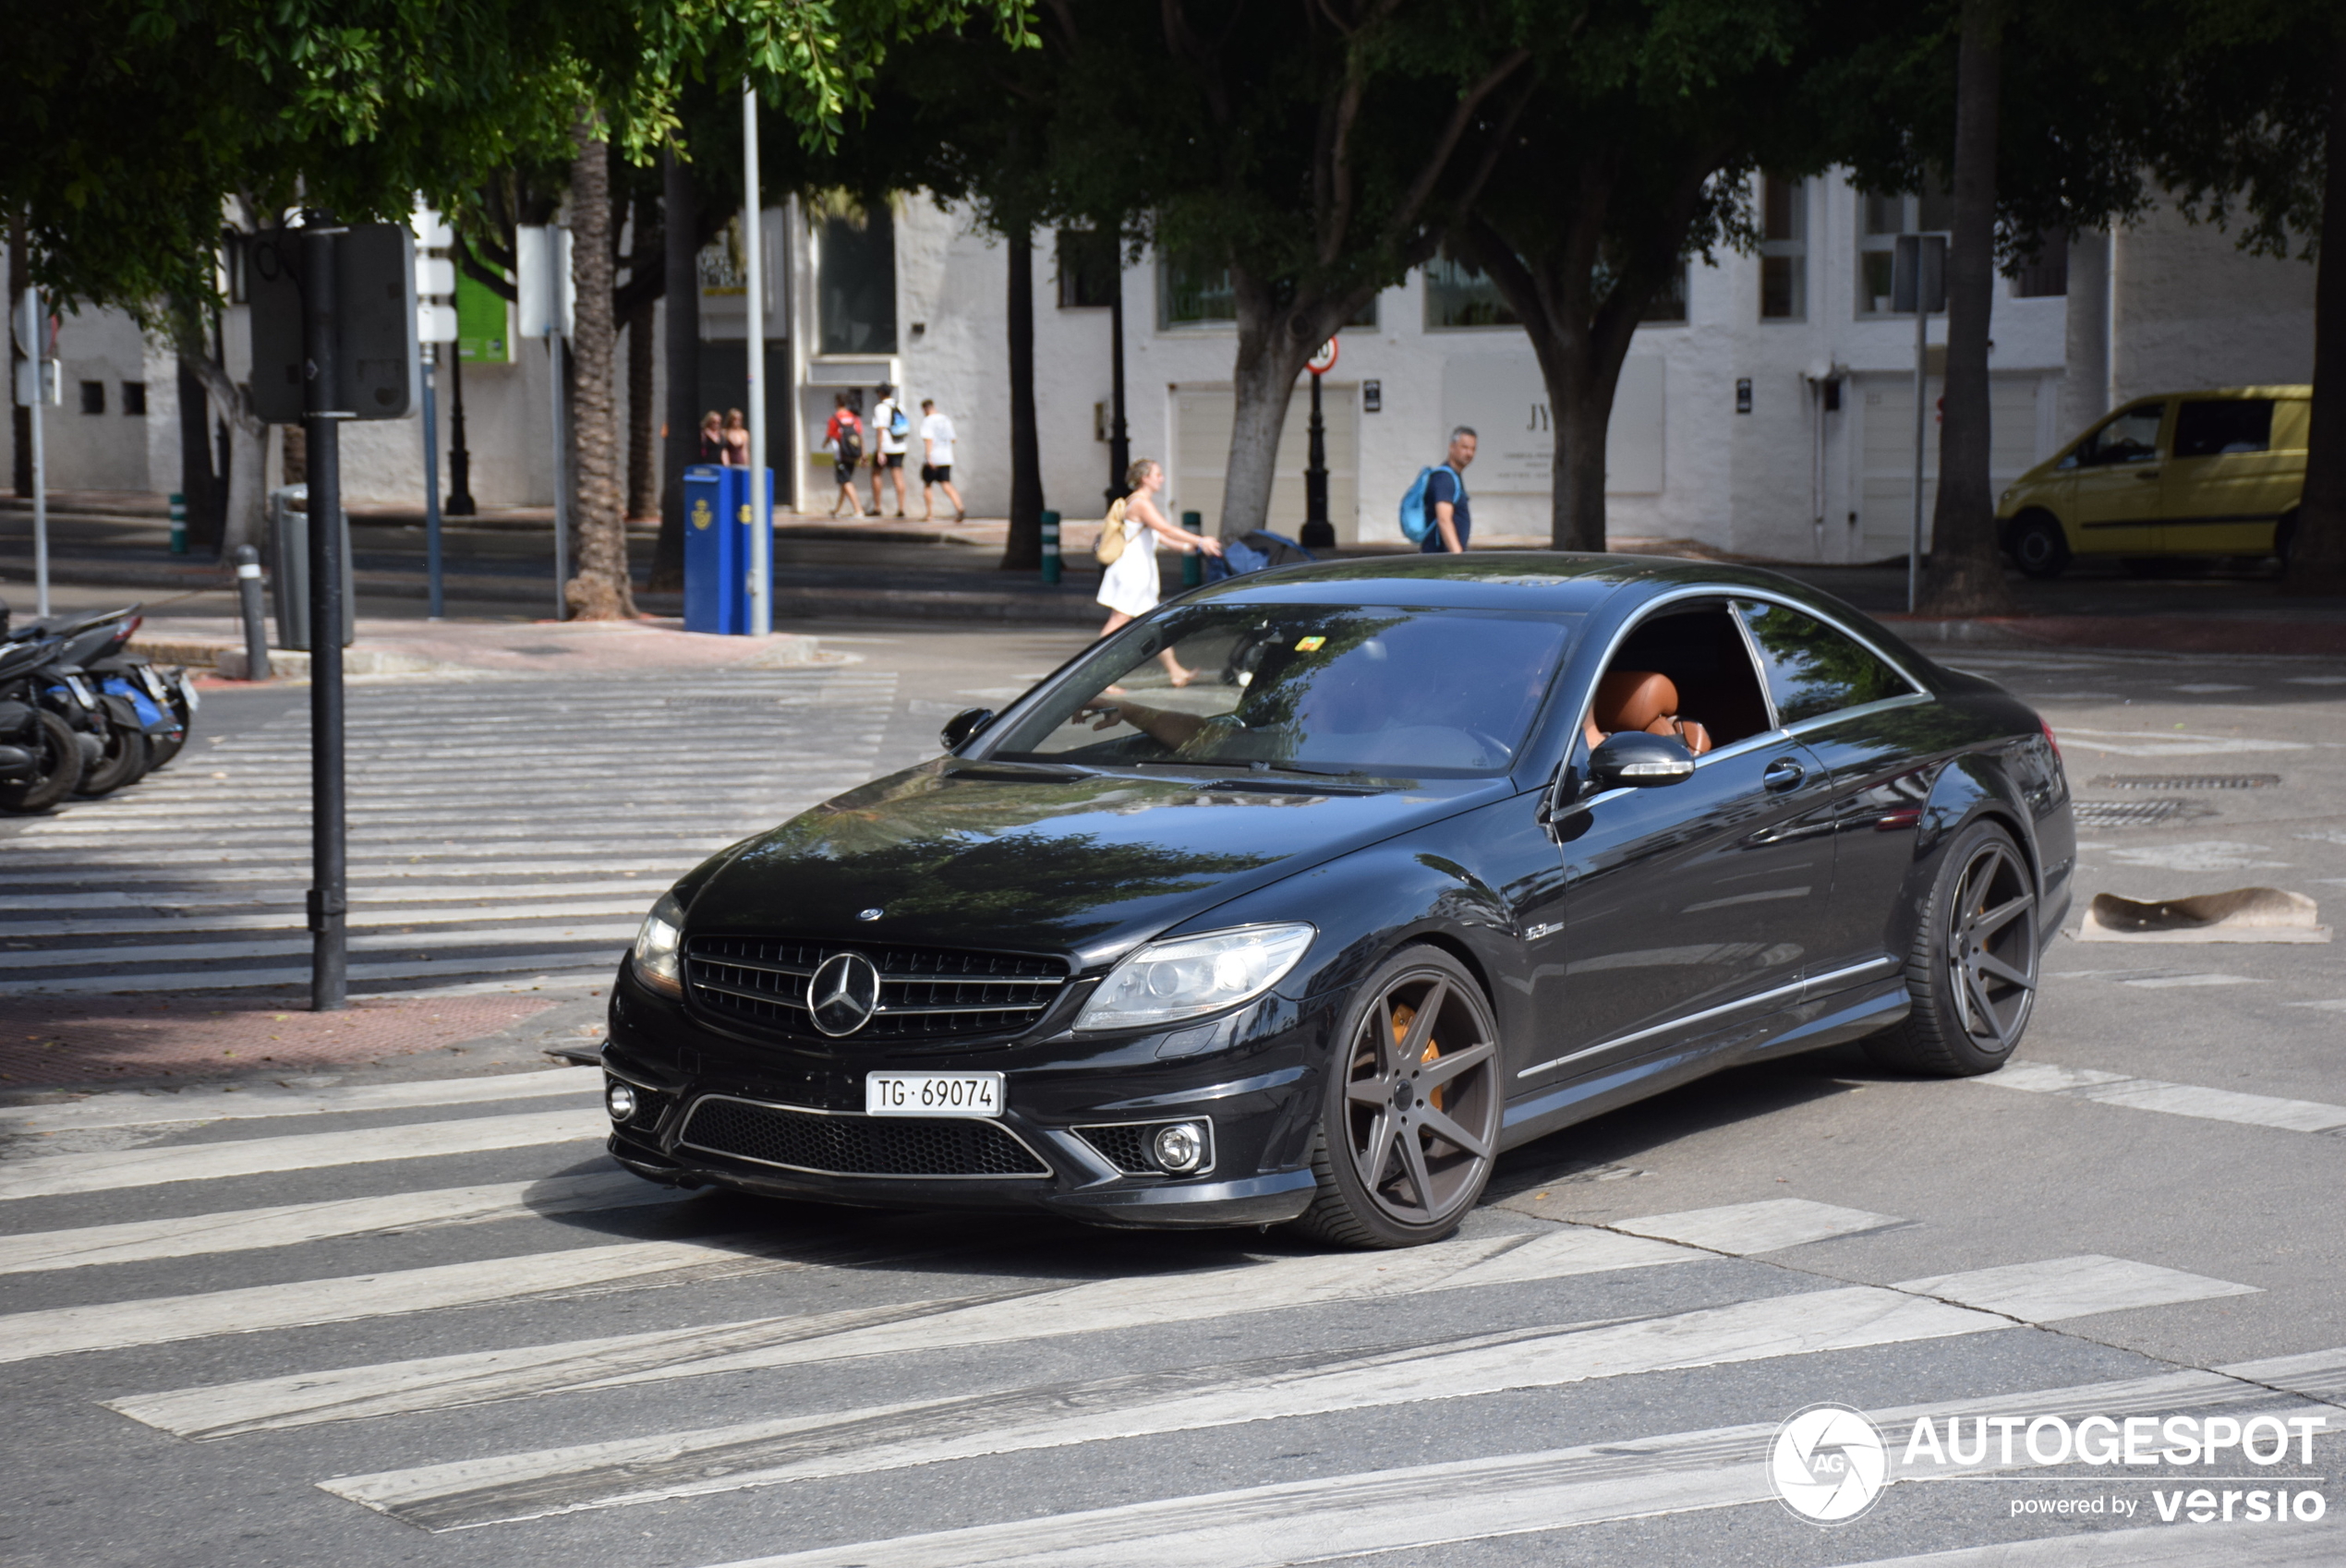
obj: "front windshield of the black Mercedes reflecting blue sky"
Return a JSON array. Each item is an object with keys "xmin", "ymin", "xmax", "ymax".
[{"xmin": 987, "ymin": 605, "xmax": 1578, "ymax": 776}]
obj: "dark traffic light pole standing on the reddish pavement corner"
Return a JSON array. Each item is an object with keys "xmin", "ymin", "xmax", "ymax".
[{"xmin": 300, "ymin": 221, "xmax": 349, "ymax": 1012}]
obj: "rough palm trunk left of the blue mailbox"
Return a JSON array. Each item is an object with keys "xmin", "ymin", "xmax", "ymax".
[{"xmin": 563, "ymin": 113, "xmax": 635, "ymax": 621}]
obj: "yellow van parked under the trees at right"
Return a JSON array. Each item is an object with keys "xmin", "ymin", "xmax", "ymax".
[{"xmin": 1997, "ymin": 387, "xmax": 2313, "ymax": 576}]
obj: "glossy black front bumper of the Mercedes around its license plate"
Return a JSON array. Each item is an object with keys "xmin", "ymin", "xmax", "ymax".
[{"xmin": 603, "ymin": 966, "xmax": 1333, "ymax": 1228}]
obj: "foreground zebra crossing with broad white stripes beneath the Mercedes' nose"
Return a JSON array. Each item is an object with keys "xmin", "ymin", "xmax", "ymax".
[{"xmin": 0, "ymin": 1068, "xmax": 2346, "ymax": 1568}]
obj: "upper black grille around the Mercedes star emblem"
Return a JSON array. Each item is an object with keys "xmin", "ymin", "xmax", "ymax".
[{"xmin": 685, "ymin": 935, "xmax": 1068, "ymax": 1043}]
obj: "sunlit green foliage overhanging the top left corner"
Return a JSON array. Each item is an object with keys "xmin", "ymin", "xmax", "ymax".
[{"xmin": 0, "ymin": 0, "xmax": 1025, "ymax": 309}]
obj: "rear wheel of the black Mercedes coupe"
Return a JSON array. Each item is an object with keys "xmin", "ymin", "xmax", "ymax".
[{"xmin": 1865, "ymin": 820, "xmax": 2038, "ymax": 1079}]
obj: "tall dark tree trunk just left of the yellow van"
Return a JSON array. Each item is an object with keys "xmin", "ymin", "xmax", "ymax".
[{"xmin": 1921, "ymin": 0, "xmax": 2013, "ymax": 617}]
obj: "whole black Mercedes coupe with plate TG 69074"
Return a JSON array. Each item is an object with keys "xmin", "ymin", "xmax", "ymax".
[{"xmin": 603, "ymin": 550, "xmax": 2076, "ymax": 1247}]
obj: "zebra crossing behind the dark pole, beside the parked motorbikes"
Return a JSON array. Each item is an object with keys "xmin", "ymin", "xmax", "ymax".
[{"xmin": 0, "ymin": 666, "xmax": 911, "ymax": 996}]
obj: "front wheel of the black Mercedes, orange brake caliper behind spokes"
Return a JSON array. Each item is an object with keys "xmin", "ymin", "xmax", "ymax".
[{"xmin": 1295, "ymin": 945, "xmax": 1504, "ymax": 1247}]
